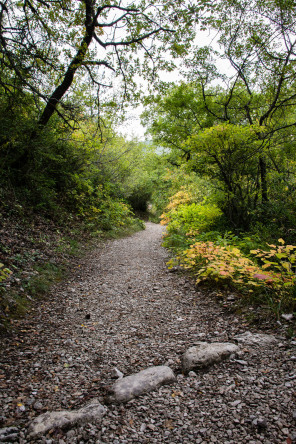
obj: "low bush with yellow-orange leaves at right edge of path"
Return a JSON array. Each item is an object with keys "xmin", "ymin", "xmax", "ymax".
[{"xmin": 168, "ymin": 239, "xmax": 296, "ymax": 314}]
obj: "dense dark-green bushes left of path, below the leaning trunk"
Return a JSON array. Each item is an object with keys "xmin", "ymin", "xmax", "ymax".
[{"xmin": 0, "ymin": 81, "xmax": 147, "ymax": 231}]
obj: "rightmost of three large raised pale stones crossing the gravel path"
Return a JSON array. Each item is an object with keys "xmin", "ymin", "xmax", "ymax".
[{"xmin": 182, "ymin": 342, "xmax": 239, "ymax": 373}]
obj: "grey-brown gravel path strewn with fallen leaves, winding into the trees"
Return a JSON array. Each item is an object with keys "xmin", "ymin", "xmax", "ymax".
[{"xmin": 0, "ymin": 223, "xmax": 296, "ymax": 444}]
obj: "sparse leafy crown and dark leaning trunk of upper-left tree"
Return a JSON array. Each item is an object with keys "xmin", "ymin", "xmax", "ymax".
[{"xmin": 0, "ymin": 0, "xmax": 199, "ymax": 126}]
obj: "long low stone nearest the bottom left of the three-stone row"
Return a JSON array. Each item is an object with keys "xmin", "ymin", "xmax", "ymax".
[{"xmin": 29, "ymin": 399, "xmax": 106, "ymax": 437}]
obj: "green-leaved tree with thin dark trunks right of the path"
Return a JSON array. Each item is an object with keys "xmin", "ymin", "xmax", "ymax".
[{"xmin": 143, "ymin": 0, "xmax": 296, "ymax": 227}]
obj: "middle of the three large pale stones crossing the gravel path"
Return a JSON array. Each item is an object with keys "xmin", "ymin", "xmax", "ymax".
[{"xmin": 106, "ymin": 365, "xmax": 176, "ymax": 403}]
